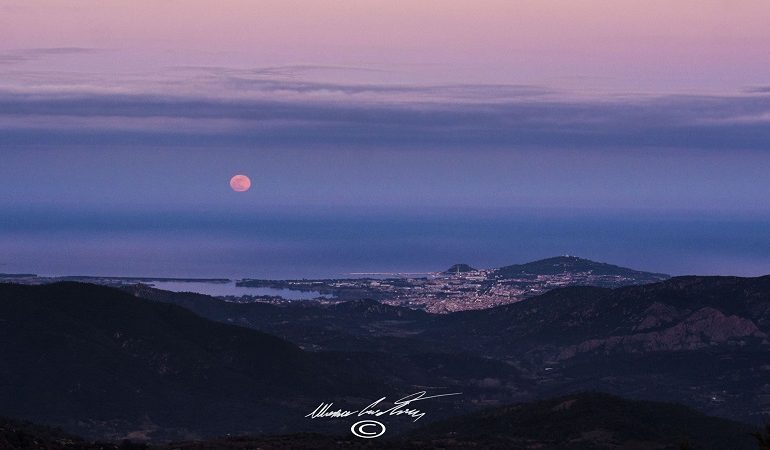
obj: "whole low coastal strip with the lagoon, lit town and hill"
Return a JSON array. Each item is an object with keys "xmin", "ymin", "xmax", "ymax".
[{"xmin": 3, "ymin": 256, "xmax": 669, "ymax": 314}]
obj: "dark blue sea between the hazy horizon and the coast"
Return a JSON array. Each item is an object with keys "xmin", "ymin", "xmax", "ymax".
[{"xmin": 0, "ymin": 210, "xmax": 770, "ymax": 279}]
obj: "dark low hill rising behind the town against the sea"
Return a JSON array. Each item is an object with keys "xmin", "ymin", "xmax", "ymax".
[{"xmin": 492, "ymin": 256, "xmax": 669, "ymax": 284}]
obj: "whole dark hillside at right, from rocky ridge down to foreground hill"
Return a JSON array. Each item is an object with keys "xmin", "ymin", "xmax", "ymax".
[{"xmin": 421, "ymin": 276, "xmax": 770, "ymax": 423}]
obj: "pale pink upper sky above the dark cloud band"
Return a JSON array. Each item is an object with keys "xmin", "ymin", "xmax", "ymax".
[{"xmin": 0, "ymin": 0, "xmax": 770, "ymax": 93}]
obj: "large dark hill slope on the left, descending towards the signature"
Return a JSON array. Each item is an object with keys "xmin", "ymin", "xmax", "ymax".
[{"xmin": 0, "ymin": 283, "xmax": 527, "ymax": 440}]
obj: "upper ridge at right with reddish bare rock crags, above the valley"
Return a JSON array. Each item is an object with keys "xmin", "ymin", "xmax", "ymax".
[{"xmin": 441, "ymin": 276, "xmax": 770, "ymax": 359}]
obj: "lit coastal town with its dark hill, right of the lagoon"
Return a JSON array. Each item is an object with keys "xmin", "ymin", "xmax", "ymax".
[{"xmin": 237, "ymin": 256, "xmax": 668, "ymax": 313}]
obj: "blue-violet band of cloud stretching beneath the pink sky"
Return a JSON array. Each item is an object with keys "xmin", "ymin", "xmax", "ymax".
[{"xmin": 0, "ymin": 78, "xmax": 770, "ymax": 150}]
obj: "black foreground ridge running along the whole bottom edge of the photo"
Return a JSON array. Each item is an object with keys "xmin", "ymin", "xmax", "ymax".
[{"xmin": 0, "ymin": 393, "xmax": 759, "ymax": 450}]
